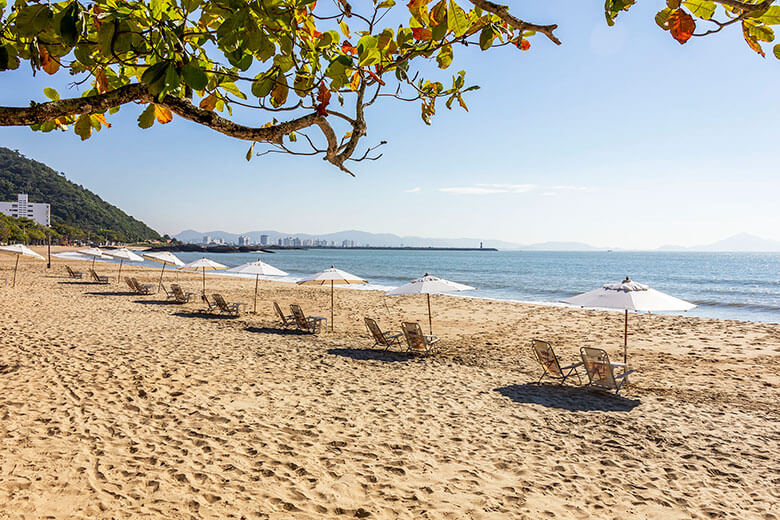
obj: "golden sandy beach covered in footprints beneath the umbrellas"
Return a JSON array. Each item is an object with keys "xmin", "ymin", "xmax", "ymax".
[{"xmin": 0, "ymin": 248, "xmax": 780, "ymax": 520}]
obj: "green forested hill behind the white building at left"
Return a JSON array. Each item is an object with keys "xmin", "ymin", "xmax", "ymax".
[{"xmin": 0, "ymin": 147, "xmax": 160, "ymax": 242}]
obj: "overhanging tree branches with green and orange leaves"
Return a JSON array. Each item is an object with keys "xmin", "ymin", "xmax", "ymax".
[{"xmin": 0, "ymin": 0, "xmax": 780, "ymax": 172}]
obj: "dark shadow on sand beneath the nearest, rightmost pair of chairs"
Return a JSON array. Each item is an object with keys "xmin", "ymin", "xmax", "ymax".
[{"xmin": 494, "ymin": 383, "xmax": 641, "ymax": 412}]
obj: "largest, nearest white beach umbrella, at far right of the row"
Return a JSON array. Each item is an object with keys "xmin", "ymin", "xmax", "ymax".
[{"xmin": 561, "ymin": 277, "xmax": 696, "ymax": 363}]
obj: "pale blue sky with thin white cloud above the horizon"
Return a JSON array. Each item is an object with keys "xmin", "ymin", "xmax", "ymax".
[{"xmin": 0, "ymin": 0, "xmax": 780, "ymax": 248}]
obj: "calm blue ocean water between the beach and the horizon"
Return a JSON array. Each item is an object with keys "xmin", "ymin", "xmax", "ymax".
[{"xmin": 62, "ymin": 249, "xmax": 780, "ymax": 323}]
